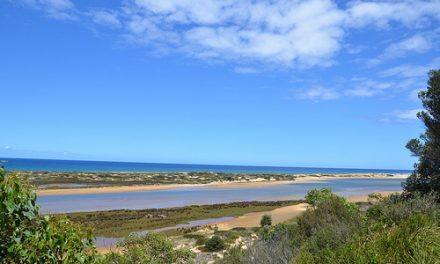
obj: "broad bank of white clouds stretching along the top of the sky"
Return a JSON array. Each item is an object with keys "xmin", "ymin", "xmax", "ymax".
[{"xmin": 8, "ymin": 0, "xmax": 440, "ymax": 68}]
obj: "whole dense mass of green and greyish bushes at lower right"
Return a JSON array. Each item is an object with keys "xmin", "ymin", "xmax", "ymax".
[{"xmin": 217, "ymin": 189, "xmax": 440, "ymax": 264}]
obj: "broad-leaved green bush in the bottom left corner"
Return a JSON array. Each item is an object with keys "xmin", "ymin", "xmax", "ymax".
[{"xmin": 0, "ymin": 168, "xmax": 96, "ymax": 263}]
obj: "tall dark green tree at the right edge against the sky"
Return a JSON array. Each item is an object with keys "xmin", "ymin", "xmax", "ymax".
[{"xmin": 403, "ymin": 70, "xmax": 440, "ymax": 194}]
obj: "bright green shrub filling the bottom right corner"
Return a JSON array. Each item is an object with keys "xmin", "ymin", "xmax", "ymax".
[{"xmin": 328, "ymin": 214, "xmax": 440, "ymax": 264}]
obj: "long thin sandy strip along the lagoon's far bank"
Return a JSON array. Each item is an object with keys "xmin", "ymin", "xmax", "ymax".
[{"xmin": 36, "ymin": 173, "xmax": 409, "ymax": 196}]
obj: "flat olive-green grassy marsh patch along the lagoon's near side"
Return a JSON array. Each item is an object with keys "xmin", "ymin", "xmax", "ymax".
[{"xmin": 61, "ymin": 201, "xmax": 302, "ymax": 237}]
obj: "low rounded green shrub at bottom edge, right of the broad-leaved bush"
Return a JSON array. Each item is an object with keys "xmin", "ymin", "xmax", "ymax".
[{"xmin": 100, "ymin": 233, "xmax": 195, "ymax": 264}]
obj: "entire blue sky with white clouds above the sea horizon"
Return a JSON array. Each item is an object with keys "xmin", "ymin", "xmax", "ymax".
[{"xmin": 0, "ymin": 0, "xmax": 440, "ymax": 169}]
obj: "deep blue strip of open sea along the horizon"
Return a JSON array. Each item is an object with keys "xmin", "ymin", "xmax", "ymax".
[{"xmin": 0, "ymin": 157, "xmax": 411, "ymax": 174}]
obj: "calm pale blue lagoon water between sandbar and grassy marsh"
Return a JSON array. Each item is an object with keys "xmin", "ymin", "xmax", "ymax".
[{"xmin": 37, "ymin": 178, "xmax": 403, "ymax": 213}]
